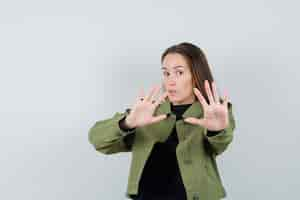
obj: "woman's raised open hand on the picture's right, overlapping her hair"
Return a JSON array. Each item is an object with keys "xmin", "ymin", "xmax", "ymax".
[{"xmin": 184, "ymin": 80, "xmax": 229, "ymax": 131}]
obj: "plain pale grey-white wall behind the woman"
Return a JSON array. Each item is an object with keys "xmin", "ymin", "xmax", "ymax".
[{"xmin": 0, "ymin": 0, "xmax": 300, "ymax": 200}]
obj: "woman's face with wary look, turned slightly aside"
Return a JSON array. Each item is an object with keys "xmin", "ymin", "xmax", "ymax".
[{"xmin": 161, "ymin": 53, "xmax": 195, "ymax": 105}]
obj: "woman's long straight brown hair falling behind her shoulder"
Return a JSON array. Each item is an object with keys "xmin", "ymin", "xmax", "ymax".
[{"xmin": 161, "ymin": 42, "xmax": 214, "ymax": 102}]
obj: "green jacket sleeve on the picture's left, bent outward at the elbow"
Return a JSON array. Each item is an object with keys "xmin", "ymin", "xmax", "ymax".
[{"xmin": 88, "ymin": 109, "xmax": 136, "ymax": 154}]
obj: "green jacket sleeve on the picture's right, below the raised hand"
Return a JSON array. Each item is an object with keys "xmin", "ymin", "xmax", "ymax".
[{"xmin": 204, "ymin": 102, "xmax": 235, "ymax": 155}]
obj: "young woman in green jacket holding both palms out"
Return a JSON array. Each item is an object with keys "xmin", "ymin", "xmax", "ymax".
[{"xmin": 89, "ymin": 42, "xmax": 235, "ymax": 200}]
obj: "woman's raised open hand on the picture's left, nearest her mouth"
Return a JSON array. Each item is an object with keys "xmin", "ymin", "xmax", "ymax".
[{"xmin": 125, "ymin": 86, "xmax": 168, "ymax": 128}]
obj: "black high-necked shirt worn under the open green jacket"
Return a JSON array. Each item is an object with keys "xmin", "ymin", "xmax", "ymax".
[{"xmin": 134, "ymin": 104, "xmax": 192, "ymax": 200}]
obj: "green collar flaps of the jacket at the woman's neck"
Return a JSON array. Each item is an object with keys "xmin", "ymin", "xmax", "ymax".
[{"xmin": 157, "ymin": 98, "xmax": 203, "ymax": 118}]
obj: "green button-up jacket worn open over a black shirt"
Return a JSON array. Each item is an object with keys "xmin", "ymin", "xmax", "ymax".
[{"xmin": 88, "ymin": 99, "xmax": 235, "ymax": 200}]
